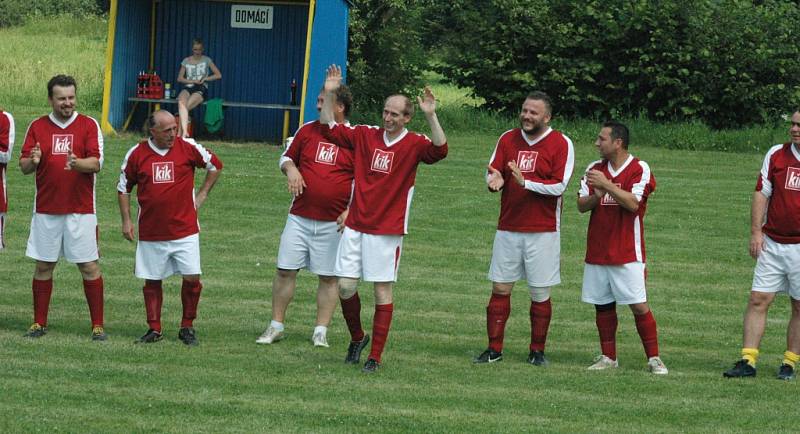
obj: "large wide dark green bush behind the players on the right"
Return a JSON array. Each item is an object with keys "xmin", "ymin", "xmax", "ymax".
[{"xmin": 433, "ymin": 0, "xmax": 800, "ymax": 128}]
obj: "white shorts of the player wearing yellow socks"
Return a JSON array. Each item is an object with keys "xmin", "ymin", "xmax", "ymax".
[{"xmin": 752, "ymin": 235, "xmax": 800, "ymax": 300}]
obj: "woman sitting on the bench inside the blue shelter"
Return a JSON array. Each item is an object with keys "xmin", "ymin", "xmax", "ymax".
[{"xmin": 178, "ymin": 38, "xmax": 222, "ymax": 138}]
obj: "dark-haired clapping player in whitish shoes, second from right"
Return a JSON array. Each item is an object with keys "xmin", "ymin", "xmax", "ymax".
[{"xmin": 578, "ymin": 122, "xmax": 669, "ymax": 375}]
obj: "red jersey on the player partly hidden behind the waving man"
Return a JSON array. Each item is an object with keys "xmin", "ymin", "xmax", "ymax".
[{"xmin": 279, "ymin": 121, "xmax": 353, "ymax": 221}]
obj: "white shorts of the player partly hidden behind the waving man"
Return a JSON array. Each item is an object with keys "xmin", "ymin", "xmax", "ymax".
[{"xmin": 277, "ymin": 214, "xmax": 341, "ymax": 276}]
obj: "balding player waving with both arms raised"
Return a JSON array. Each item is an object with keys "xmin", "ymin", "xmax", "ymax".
[{"xmin": 320, "ymin": 65, "xmax": 447, "ymax": 373}]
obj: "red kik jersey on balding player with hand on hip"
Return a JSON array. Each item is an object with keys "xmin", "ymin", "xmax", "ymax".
[{"xmin": 117, "ymin": 137, "xmax": 222, "ymax": 241}]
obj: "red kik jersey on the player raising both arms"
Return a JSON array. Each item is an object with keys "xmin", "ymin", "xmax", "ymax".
[{"xmin": 324, "ymin": 122, "xmax": 447, "ymax": 235}]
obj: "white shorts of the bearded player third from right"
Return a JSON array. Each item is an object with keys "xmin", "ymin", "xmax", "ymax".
[{"xmin": 489, "ymin": 231, "xmax": 561, "ymax": 288}]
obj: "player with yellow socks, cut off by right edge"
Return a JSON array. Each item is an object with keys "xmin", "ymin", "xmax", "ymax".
[{"xmin": 723, "ymin": 110, "xmax": 800, "ymax": 380}]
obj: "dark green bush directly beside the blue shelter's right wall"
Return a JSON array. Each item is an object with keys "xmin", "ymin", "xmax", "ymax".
[{"xmin": 347, "ymin": 0, "xmax": 427, "ymax": 112}]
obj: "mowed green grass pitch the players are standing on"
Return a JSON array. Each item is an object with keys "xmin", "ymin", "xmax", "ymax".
[{"xmin": 0, "ymin": 13, "xmax": 797, "ymax": 433}]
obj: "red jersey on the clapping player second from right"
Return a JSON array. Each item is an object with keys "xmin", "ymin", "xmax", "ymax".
[{"xmin": 578, "ymin": 155, "xmax": 656, "ymax": 265}]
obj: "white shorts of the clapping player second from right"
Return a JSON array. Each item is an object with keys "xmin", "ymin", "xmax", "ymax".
[{"xmin": 581, "ymin": 262, "xmax": 647, "ymax": 305}]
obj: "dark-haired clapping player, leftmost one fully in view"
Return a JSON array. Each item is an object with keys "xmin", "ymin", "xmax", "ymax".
[{"xmin": 19, "ymin": 75, "xmax": 107, "ymax": 341}]
